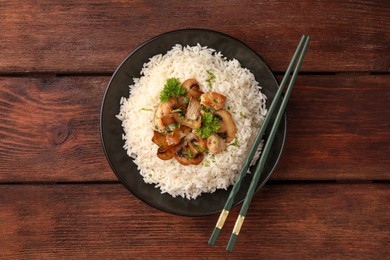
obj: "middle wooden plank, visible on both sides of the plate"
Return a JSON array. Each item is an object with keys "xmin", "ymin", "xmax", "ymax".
[{"xmin": 0, "ymin": 75, "xmax": 390, "ymax": 182}]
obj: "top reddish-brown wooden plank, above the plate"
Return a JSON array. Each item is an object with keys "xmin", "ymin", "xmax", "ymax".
[{"xmin": 0, "ymin": 0, "xmax": 390, "ymax": 73}]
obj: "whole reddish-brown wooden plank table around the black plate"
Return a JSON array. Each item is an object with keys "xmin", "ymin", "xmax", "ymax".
[{"xmin": 0, "ymin": 0, "xmax": 390, "ymax": 259}]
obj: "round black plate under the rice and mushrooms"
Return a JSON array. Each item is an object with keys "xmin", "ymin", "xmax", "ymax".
[{"xmin": 100, "ymin": 29, "xmax": 286, "ymax": 216}]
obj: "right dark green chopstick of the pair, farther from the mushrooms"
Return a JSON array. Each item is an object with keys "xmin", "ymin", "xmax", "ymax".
[{"xmin": 226, "ymin": 36, "xmax": 310, "ymax": 251}]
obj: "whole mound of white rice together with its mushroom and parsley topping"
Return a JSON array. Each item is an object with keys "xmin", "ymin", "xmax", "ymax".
[{"xmin": 117, "ymin": 44, "xmax": 267, "ymax": 199}]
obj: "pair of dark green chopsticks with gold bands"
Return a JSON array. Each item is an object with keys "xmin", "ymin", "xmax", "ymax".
[{"xmin": 208, "ymin": 35, "xmax": 310, "ymax": 252}]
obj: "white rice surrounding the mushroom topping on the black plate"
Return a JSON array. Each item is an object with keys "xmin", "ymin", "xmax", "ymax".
[{"xmin": 117, "ymin": 44, "xmax": 267, "ymax": 199}]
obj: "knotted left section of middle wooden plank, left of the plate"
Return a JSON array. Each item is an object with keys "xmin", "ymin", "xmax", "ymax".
[{"xmin": 0, "ymin": 77, "xmax": 115, "ymax": 182}]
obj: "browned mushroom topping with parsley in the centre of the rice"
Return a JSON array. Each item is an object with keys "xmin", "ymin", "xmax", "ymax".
[{"xmin": 152, "ymin": 78, "xmax": 237, "ymax": 165}]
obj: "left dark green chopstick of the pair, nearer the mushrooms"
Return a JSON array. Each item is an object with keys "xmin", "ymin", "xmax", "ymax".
[{"xmin": 208, "ymin": 36, "xmax": 306, "ymax": 248}]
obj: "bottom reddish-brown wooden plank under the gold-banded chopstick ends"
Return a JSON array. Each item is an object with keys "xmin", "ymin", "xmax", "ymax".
[{"xmin": 0, "ymin": 184, "xmax": 390, "ymax": 259}]
